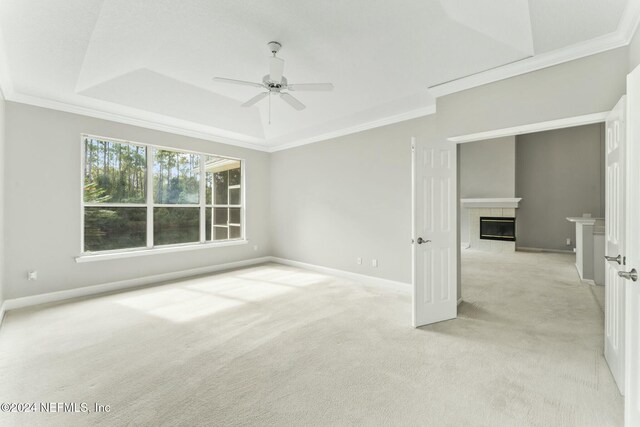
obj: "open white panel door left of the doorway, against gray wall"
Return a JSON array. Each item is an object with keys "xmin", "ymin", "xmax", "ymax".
[{"xmin": 412, "ymin": 138, "xmax": 458, "ymax": 327}]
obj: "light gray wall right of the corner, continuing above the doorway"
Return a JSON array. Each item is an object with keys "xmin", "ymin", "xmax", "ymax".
[{"xmin": 271, "ymin": 48, "xmax": 629, "ymax": 294}]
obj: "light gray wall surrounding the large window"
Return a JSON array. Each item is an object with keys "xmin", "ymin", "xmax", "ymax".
[{"xmin": 5, "ymin": 102, "xmax": 270, "ymax": 298}]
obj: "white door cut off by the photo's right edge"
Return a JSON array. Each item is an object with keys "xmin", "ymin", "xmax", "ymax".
[{"xmin": 621, "ymin": 63, "xmax": 640, "ymax": 427}]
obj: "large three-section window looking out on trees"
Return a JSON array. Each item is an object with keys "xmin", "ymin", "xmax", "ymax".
[{"xmin": 82, "ymin": 135, "xmax": 244, "ymax": 253}]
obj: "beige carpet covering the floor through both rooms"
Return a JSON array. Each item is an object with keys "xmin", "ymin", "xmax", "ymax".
[{"xmin": 0, "ymin": 250, "xmax": 623, "ymax": 427}]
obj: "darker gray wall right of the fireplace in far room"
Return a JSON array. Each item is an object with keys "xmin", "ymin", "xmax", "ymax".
[{"xmin": 516, "ymin": 124, "xmax": 604, "ymax": 250}]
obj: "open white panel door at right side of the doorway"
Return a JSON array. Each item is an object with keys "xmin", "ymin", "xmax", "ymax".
[{"xmin": 608, "ymin": 97, "xmax": 626, "ymax": 394}]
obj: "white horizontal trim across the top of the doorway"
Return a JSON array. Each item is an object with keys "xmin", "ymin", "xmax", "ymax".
[{"xmin": 447, "ymin": 111, "xmax": 609, "ymax": 144}]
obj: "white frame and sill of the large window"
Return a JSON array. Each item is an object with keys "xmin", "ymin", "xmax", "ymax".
[{"xmin": 76, "ymin": 133, "xmax": 248, "ymax": 262}]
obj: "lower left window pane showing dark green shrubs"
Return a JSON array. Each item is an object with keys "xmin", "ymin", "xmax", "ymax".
[{"xmin": 84, "ymin": 208, "xmax": 147, "ymax": 252}]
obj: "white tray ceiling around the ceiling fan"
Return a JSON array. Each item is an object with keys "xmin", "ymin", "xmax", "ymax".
[{"xmin": 0, "ymin": 0, "xmax": 634, "ymax": 149}]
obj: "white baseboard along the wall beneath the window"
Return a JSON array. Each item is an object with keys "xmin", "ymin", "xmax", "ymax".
[{"xmin": 0, "ymin": 256, "xmax": 271, "ymax": 313}]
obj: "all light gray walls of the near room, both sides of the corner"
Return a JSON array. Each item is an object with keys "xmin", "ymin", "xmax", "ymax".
[{"xmin": 4, "ymin": 42, "xmax": 631, "ymax": 298}]
